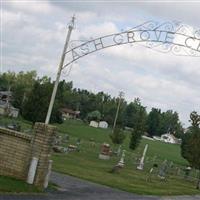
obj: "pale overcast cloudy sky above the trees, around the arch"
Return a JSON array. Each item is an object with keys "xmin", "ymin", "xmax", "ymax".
[{"xmin": 1, "ymin": 0, "xmax": 200, "ymax": 125}]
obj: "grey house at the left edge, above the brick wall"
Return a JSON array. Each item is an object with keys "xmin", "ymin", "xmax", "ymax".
[{"xmin": 0, "ymin": 91, "xmax": 19, "ymax": 117}]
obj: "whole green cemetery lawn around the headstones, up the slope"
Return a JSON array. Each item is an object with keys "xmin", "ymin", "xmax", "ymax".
[{"xmin": 52, "ymin": 120, "xmax": 200, "ymax": 195}]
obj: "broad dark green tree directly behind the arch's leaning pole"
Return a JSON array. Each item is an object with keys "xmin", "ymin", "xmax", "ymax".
[{"xmin": 23, "ymin": 77, "xmax": 64, "ymax": 123}]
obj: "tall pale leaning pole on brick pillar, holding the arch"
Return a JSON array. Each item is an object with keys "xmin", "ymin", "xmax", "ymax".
[{"xmin": 45, "ymin": 16, "xmax": 75, "ymax": 124}]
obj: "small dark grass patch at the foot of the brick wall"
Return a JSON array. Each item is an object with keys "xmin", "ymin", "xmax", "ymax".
[{"xmin": 0, "ymin": 176, "xmax": 41, "ymax": 193}]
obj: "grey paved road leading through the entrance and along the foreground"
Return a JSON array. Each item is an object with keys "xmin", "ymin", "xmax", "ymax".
[{"xmin": 0, "ymin": 172, "xmax": 200, "ymax": 200}]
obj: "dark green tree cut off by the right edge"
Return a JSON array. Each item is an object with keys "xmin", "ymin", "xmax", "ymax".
[{"xmin": 181, "ymin": 111, "xmax": 200, "ymax": 189}]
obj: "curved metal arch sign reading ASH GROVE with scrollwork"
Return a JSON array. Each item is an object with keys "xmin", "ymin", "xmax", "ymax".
[{"xmin": 63, "ymin": 21, "xmax": 200, "ymax": 68}]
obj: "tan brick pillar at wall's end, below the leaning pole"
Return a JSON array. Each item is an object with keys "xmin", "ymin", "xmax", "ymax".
[{"xmin": 32, "ymin": 122, "xmax": 56, "ymax": 188}]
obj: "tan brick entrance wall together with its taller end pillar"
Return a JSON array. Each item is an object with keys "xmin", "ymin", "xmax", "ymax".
[{"xmin": 0, "ymin": 123, "xmax": 55, "ymax": 187}]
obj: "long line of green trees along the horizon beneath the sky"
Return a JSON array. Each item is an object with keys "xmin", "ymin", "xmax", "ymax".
[{"xmin": 0, "ymin": 71, "xmax": 183, "ymax": 138}]
